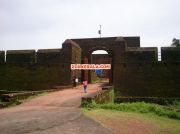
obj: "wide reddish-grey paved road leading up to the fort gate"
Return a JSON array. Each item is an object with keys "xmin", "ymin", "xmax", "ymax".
[{"xmin": 0, "ymin": 84, "xmax": 111, "ymax": 134}]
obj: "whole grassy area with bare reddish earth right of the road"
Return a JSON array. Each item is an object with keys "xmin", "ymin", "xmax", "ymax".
[{"xmin": 82, "ymin": 101, "xmax": 180, "ymax": 134}]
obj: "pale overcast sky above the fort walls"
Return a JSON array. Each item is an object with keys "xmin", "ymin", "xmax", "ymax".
[{"xmin": 0, "ymin": 0, "xmax": 180, "ymax": 50}]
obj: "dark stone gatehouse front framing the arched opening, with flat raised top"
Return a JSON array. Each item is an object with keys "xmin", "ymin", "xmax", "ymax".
[{"xmin": 63, "ymin": 37, "xmax": 140, "ymax": 84}]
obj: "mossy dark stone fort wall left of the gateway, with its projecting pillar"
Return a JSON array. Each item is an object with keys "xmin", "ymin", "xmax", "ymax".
[{"xmin": 0, "ymin": 42, "xmax": 81, "ymax": 90}]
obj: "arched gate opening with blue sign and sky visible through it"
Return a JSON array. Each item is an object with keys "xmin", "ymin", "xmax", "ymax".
[{"xmin": 83, "ymin": 47, "xmax": 113, "ymax": 85}]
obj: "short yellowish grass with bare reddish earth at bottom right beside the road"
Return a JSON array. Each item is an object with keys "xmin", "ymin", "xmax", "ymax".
[{"xmin": 82, "ymin": 108, "xmax": 180, "ymax": 134}]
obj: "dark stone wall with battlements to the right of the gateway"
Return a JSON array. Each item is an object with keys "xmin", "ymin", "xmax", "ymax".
[{"xmin": 114, "ymin": 48, "xmax": 180, "ymax": 98}]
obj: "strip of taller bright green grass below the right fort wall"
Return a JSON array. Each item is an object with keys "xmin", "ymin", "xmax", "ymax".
[{"xmin": 84, "ymin": 102, "xmax": 180, "ymax": 120}]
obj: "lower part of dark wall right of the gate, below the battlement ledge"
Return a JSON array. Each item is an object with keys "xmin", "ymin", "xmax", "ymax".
[{"xmin": 113, "ymin": 62, "xmax": 180, "ymax": 97}]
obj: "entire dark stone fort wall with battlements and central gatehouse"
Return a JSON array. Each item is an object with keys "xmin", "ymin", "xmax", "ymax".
[{"xmin": 0, "ymin": 37, "xmax": 180, "ymax": 98}]
